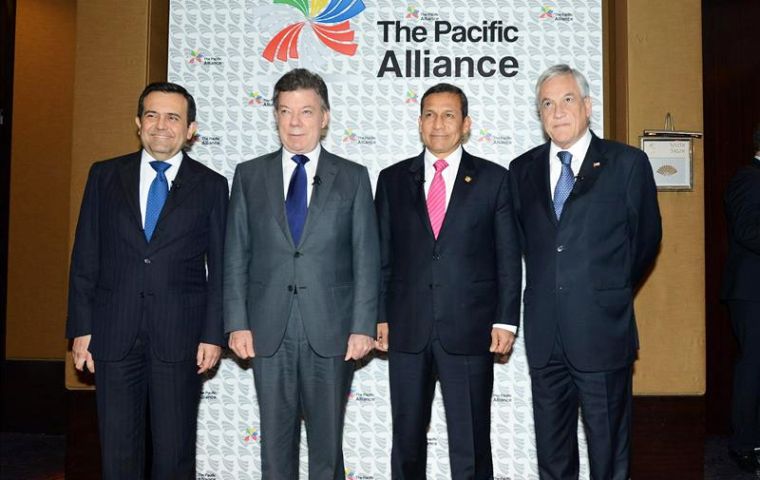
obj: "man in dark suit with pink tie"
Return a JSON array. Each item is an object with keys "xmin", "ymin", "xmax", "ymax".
[{"xmin": 375, "ymin": 84, "xmax": 521, "ymax": 480}]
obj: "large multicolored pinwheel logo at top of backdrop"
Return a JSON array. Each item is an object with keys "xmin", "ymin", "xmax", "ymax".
[{"xmin": 262, "ymin": 0, "xmax": 366, "ymax": 63}]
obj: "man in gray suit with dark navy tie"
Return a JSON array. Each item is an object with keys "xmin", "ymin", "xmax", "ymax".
[{"xmin": 224, "ymin": 69, "xmax": 380, "ymax": 479}]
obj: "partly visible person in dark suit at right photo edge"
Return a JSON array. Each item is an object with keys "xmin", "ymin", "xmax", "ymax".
[{"xmin": 721, "ymin": 125, "xmax": 760, "ymax": 473}]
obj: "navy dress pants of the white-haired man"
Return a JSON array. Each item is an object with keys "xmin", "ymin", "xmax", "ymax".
[{"xmin": 530, "ymin": 335, "xmax": 632, "ymax": 480}]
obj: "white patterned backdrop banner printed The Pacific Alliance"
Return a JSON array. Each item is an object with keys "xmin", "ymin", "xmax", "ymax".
[{"xmin": 169, "ymin": 0, "xmax": 603, "ymax": 480}]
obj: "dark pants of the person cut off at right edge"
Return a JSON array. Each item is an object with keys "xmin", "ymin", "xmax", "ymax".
[{"xmin": 728, "ymin": 300, "xmax": 760, "ymax": 453}]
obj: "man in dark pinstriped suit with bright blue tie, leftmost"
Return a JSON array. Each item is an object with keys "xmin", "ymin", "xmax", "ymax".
[{"xmin": 66, "ymin": 83, "xmax": 228, "ymax": 480}]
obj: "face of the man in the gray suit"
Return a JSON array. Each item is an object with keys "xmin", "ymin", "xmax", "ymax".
[{"xmin": 275, "ymin": 89, "xmax": 330, "ymax": 154}]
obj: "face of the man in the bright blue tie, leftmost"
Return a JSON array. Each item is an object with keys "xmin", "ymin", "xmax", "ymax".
[{"xmin": 135, "ymin": 92, "xmax": 197, "ymax": 160}]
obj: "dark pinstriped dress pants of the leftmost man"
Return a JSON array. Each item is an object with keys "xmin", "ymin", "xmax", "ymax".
[{"xmin": 95, "ymin": 334, "xmax": 201, "ymax": 480}]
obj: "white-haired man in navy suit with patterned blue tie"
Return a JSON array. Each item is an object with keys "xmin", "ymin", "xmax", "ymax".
[{"xmin": 510, "ymin": 65, "xmax": 662, "ymax": 480}]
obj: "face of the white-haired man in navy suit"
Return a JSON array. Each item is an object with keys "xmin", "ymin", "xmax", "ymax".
[{"xmin": 538, "ymin": 74, "xmax": 591, "ymax": 149}]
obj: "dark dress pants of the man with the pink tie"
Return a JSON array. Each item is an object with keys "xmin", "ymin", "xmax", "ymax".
[{"xmin": 388, "ymin": 336, "xmax": 493, "ymax": 480}]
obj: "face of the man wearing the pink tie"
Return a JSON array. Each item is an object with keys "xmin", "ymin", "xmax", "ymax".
[{"xmin": 419, "ymin": 92, "xmax": 471, "ymax": 158}]
